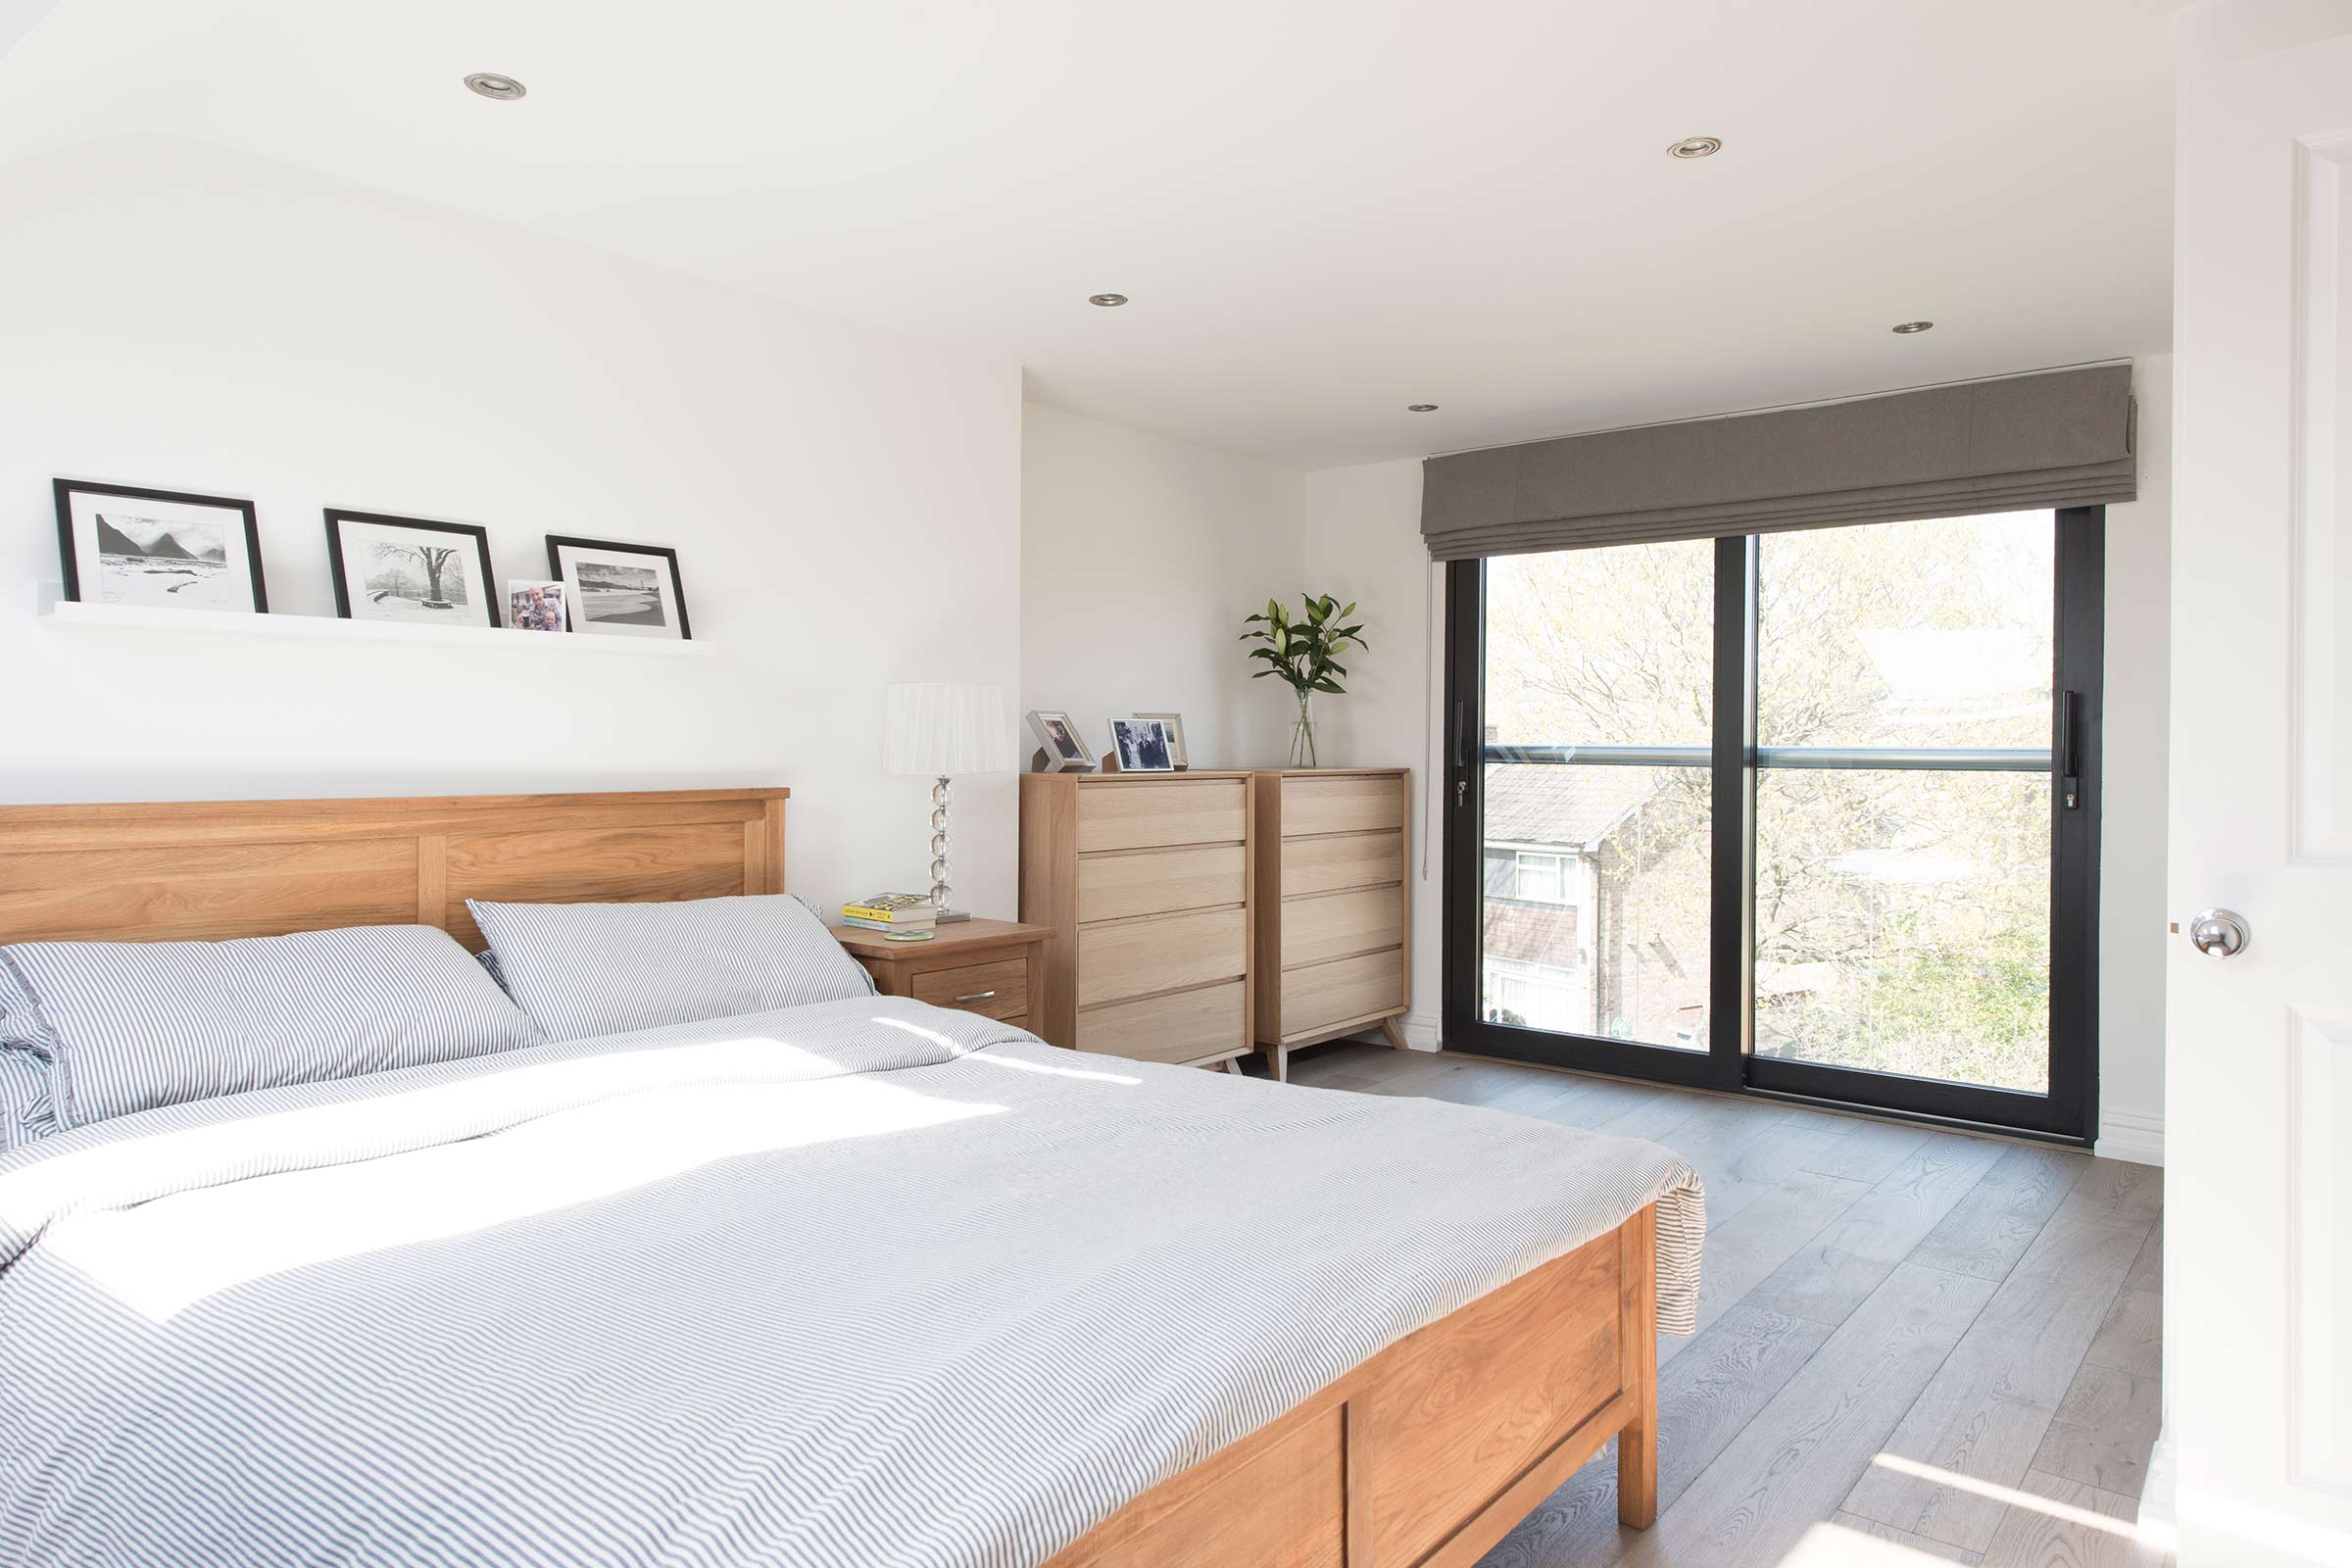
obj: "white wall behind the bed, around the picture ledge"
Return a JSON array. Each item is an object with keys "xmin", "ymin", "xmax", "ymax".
[{"xmin": 0, "ymin": 136, "xmax": 1030, "ymax": 914}]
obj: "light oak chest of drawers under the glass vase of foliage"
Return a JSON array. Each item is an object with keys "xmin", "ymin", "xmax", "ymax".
[{"xmin": 1251, "ymin": 768, "xmax": 1413, "ymax": 1079}]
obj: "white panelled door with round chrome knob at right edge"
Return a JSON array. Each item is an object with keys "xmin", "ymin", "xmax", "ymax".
[{"xmin": 2173, "ymin": 0, "xmax": 2352, "ymax": 1568}]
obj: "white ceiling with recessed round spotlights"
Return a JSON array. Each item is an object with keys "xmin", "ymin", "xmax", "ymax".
[{"xmin": 0, "ymin": 0, "xmax": 2171, "ymax": 467}]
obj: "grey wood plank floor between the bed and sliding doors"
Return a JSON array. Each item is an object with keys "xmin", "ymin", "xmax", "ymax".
[{"xmin": 1292, "ymin": 1042, "xmax": 2166, "ymax": 1568}]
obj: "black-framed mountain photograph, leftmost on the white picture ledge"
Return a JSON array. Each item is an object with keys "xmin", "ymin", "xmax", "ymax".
[{"xmin": 57, "ymin": 479, "xmax": 270, "ymax": 613}]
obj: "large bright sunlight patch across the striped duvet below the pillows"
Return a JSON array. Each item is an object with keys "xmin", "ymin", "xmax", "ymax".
[{"xmin": 47, "ymin": 1077, "xmax": 1004, "ymax": 1324}]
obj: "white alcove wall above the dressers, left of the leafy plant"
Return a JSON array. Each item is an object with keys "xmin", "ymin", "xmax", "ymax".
[{"xmin": 1021, "ymin": 405, "xmax": 1298, "ymax": 768}]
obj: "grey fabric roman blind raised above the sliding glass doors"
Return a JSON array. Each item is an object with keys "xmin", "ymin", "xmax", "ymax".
[{"xmin": 1421, "ymin": 365, "xmax": 2135, "ymax": 562}]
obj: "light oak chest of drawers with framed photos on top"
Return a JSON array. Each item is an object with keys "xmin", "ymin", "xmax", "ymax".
[{"xmin": 1021, "ymin": 773, "xmax": 1253, "ymax": 1072}]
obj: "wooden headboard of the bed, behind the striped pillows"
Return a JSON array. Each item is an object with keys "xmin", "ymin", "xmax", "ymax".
[{"xmin": 0, "ymin": 790, "xmax": 790, "ymax": 948}]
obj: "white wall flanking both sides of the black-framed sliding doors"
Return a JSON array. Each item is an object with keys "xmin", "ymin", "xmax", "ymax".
[{"xmin": 1305, "ymin": 355, "xmax": 2171, "ymax": 1161}]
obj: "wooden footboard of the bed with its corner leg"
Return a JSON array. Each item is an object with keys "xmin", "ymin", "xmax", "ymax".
[{"xmin": 1049, "ymin": 1206, "xmax": 1658, "ymax": 1568}]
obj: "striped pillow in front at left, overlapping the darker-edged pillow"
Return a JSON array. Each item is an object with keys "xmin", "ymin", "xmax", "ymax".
[{"xmin": 0, "ymin": 926, "xmax": 541, "ymax": 1128}]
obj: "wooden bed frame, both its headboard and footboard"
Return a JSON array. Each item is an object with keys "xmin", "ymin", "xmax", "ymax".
[{"xmin": 0, "ymin": 790, "xmax": 1658, "ymax": 1568}]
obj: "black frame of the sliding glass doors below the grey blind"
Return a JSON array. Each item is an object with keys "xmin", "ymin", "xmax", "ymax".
[{"xmin": 1440, "ymin": 506, "xmax": 2107, "ymax": 1145}]
